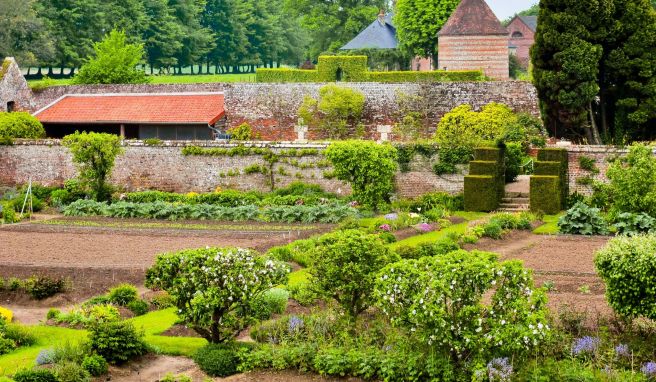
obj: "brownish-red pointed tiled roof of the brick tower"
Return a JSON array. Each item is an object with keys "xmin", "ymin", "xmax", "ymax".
[{"xmin": 438, "ymin": 0, "xmax": 508, "ymax": 36}]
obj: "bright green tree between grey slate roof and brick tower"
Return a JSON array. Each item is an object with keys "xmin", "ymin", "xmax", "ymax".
[{"xmin": 394, "ymin": 0, "xmax": 460, "ymax": 58}]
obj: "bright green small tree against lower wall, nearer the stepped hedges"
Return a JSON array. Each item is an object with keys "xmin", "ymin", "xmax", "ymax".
[{"xmin": 325, "ymin": 141, "xmax": 397, "ymax": 208}]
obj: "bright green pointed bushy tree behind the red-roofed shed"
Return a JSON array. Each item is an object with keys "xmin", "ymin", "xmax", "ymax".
[{"xmin": 73, "ymin": 29, "xmax": 148, "ymax": 84}]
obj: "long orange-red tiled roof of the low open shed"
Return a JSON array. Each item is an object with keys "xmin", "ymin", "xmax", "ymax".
[{"xmin": 34, "ymin": 93, "xmax": 225, "ymax": 125}]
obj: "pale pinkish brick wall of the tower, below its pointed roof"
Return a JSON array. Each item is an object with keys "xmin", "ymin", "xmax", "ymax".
[{"xmin": 438, "ymin": 36, "xmax": 510, "ymax": 80}]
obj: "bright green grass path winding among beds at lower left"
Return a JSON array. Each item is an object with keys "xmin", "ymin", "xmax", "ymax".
[{"xmin": 0, "ymin": 308, "xmax": 207, "ymax": 376}]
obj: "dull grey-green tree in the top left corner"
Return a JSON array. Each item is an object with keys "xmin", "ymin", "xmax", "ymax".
[{"xmin": 0, "ymin": 0, "xmax": 54, "ymax": 66}]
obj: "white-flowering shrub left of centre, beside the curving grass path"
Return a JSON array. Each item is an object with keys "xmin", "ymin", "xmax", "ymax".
[{"xmin": 146, "ymin": 248, "xmax": 289, "ymax": 343}]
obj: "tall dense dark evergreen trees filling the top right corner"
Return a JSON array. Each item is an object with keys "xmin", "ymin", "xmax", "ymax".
[{"xmin": 531, "ymin": 0, "xmax": 656, "ymax": 143}]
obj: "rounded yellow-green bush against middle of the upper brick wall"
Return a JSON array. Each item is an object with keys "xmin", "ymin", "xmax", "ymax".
[{"xmin": 298, "ymin": 84, "xmax": 365, "ymax": 139}]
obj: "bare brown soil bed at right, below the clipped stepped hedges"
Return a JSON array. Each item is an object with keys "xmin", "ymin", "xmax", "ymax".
[{"xmin": 466, "ymin": 231, "xmax": 611, "ymax": 316}]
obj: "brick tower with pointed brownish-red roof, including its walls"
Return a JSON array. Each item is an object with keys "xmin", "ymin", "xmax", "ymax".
[{"xmin": 438, "ymin": 0, "xmax": 510, "ymax": 80}]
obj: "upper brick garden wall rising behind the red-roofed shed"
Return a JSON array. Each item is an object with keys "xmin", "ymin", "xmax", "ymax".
[{"xmin": 34, "ymin": 81, "xmax": 539, "ymax": 141}]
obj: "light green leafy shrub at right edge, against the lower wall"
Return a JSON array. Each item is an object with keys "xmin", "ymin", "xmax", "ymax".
[{"xmin": 603, "ymin": 145, "xmax": 656, "ymax": 216}]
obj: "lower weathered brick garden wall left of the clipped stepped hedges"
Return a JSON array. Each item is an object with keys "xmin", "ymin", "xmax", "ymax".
[{"xmin": 0, "ymin": 140, "xmax": 464, "ymax": 197}]
